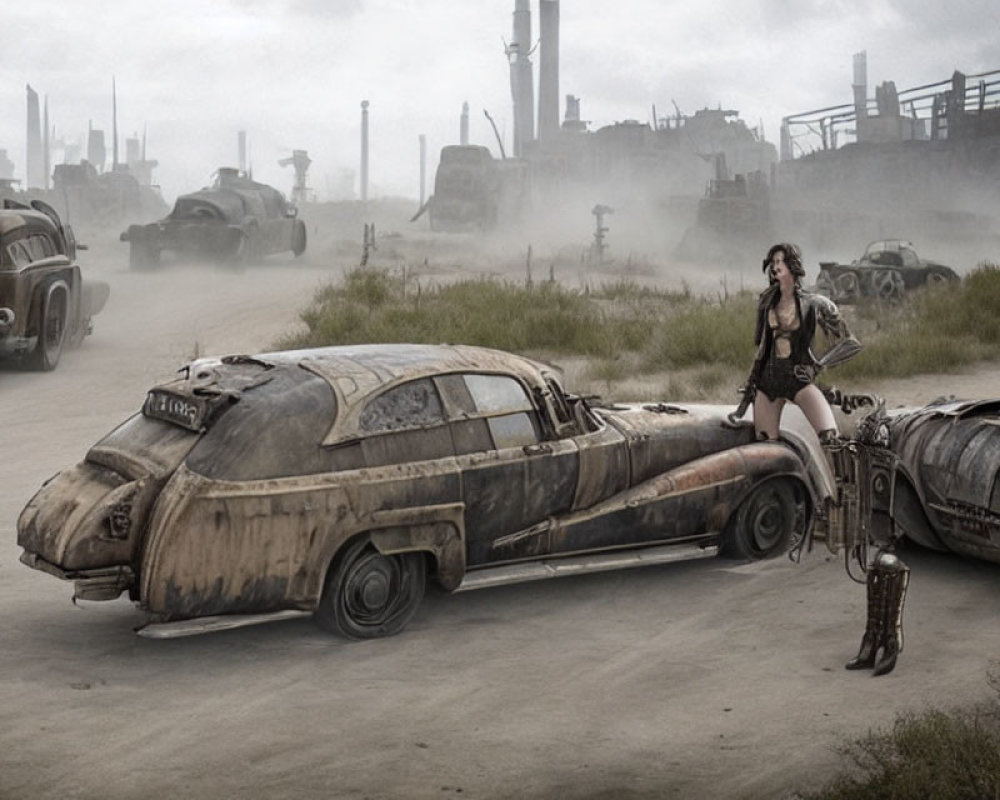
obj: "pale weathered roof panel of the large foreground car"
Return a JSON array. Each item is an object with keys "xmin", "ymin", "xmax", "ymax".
[{"xmin": 254, "ymin": 344, "xmax": 560, "ymax": 445}]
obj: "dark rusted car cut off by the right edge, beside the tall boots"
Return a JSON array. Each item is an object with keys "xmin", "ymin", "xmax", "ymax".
[{"xmin": 887, "ymin": 399, "xmax": 1000, "ymax": 563}]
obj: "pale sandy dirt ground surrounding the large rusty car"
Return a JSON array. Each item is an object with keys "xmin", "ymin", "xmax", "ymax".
[{"xmin": 0, "ymin": 238, "xmax": 1000, "ymax": 800}]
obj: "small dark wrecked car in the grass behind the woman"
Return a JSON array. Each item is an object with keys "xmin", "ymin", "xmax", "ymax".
[{"xmin": 816, "ymin": 239, "xmax": 959, "ymax": 303}]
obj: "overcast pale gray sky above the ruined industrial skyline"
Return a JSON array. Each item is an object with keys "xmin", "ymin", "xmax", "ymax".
[{"xmin": 0, "ymin": 0, "xmax": 1000, "ymax": 200}]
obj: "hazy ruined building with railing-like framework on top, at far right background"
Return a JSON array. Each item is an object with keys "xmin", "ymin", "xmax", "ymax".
[{"xmin": 772, "ymin": 53, "xmax": 1000, "ymax": 253}]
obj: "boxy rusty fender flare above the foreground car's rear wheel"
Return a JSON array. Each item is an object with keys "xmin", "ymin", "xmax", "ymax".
[{"xmin": 368, "ymin": 503, "xmax": 465, "ymax": 592}]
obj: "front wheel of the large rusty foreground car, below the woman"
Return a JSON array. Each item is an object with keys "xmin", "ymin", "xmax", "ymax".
[{"xmin": 721, "ymin": 478, "xmax": 800, "ymax": 561}]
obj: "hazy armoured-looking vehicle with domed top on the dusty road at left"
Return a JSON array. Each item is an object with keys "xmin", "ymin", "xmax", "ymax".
[{"xmin": 120, "ymin": 167, "xmax": 306, "ymax": 269}]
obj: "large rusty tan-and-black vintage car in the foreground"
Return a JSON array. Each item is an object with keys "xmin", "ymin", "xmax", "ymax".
[{"xmin": 18, "ymin": 344, "xmax": 829, "ymax": 638}]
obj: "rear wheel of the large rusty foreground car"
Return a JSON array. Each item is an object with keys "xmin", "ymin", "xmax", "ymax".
[{"xmin": 315, "ymin": 537, "xmax": 427, "ymax": 639}]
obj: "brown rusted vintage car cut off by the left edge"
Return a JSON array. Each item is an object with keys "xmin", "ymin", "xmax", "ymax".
[{"xmin": 0, "ymin": 198, "xmax": 110, "ymax": 371}]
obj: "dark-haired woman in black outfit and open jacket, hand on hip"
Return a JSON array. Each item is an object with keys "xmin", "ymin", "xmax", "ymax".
[{"xmin": 748, "ymin": 243, "xmax": 861, "ymax": 442}]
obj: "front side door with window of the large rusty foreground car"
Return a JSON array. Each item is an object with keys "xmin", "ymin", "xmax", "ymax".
[{"xmin": 437, "ymin": 373, "xmax": 578, "ymax": 567}]
